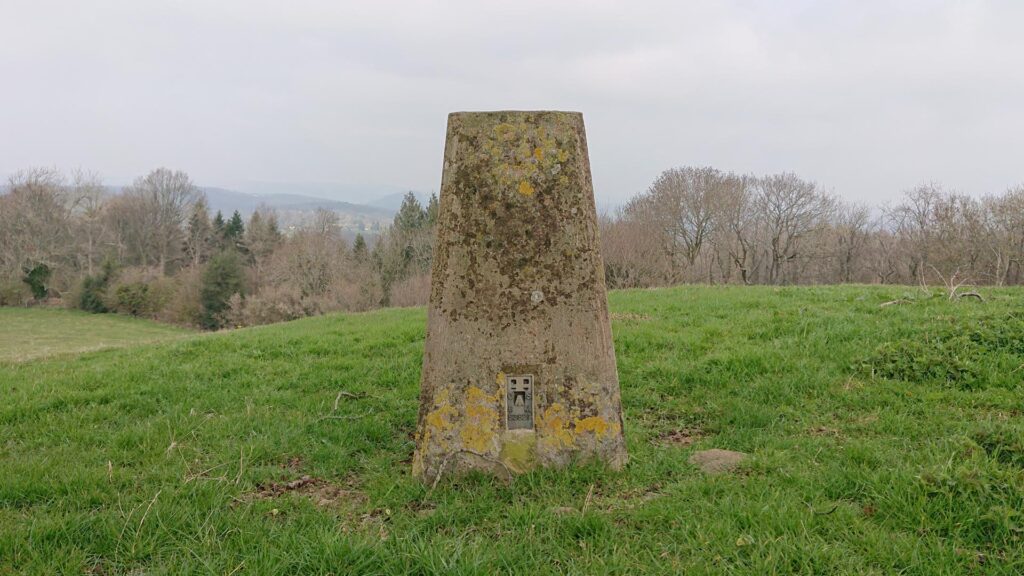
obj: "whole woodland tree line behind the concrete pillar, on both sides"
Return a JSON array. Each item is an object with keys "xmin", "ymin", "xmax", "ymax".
[{"xmin": 0, "ymin": 163, "xmax": 1024, "ymax": 329}]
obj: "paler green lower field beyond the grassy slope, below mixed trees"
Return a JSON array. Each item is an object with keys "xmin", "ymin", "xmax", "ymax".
[{"xmin": 0, "ymin": 307, "xmax": 189, "ymax": 362}]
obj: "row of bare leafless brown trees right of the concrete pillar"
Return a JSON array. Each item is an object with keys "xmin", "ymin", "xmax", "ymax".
[{"xmin": 601, "ymin": 167, "xmax": 1024, "ymax": 288}]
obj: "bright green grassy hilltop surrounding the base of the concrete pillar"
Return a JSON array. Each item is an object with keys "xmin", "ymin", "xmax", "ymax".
[{"xmin": 0, "ymin": 287, "xmax": 1024, "ymax": 575}]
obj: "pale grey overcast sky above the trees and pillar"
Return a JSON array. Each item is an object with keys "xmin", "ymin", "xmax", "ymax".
[{"xmin": 0, "ymin": 0, "xmax": 1024, "ymax": 203}]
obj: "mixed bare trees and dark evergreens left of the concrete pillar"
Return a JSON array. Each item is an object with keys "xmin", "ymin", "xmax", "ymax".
[{"xmin": 0, "ymin": 168, "xmax": 437, "ymax": 329}]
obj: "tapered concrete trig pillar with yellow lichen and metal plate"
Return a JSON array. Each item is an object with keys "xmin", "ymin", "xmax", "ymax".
[{"xmin": 413, "ymin": 112, "xmax": 627, "ymax": 482}]
